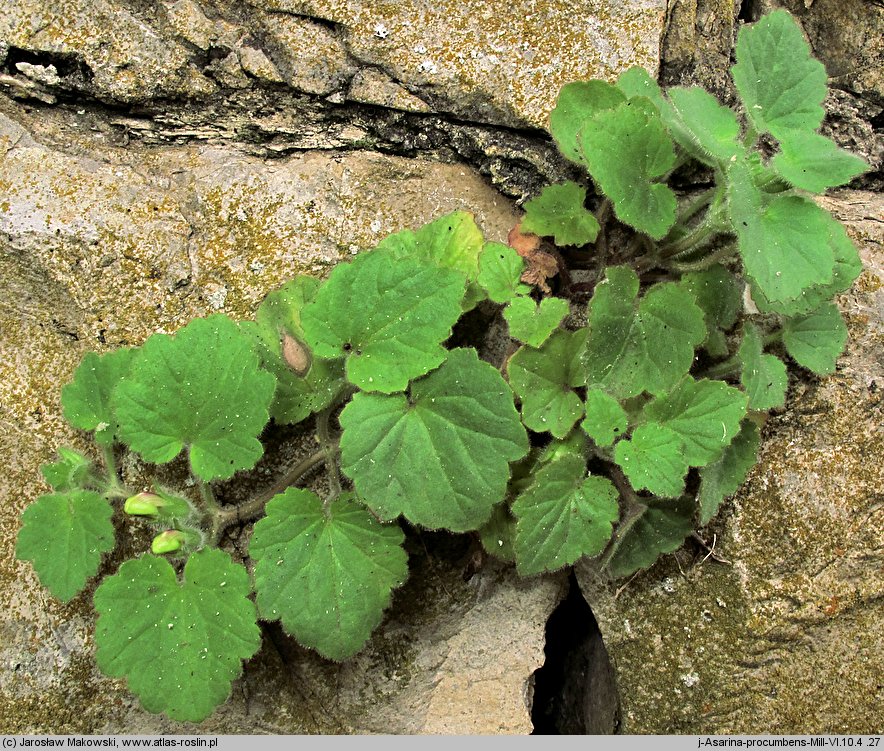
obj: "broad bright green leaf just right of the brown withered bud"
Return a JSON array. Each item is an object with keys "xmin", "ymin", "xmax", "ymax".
[{"xmin": 301, "ymin": 251, "xmax": 464, "ymax": 393}]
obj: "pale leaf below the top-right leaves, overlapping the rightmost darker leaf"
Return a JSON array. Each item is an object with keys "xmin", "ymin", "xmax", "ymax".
[{"xmin": 728, "ymin": 162, "xmax": 835, "ymax": 302}]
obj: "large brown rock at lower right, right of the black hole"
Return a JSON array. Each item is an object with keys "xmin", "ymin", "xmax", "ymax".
[{"xmin": 578, "ymin": 192, "xmax": 884, "ymax": 734}]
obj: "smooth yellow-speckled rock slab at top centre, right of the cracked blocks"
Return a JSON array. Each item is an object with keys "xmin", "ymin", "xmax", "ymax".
[{"xmin": 253, "ymin": 0, "xmax": 666, "ymax": 127}]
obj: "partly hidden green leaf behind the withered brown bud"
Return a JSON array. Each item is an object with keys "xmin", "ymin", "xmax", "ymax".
[{"xmin": 240, "ymin": 276, "xmax": 352, "ymax": 424}]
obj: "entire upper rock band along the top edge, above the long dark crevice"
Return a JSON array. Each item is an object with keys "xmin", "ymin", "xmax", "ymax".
[{"xmin": 0, "ymin": 0, "xmax": 666, "ymax": 127}]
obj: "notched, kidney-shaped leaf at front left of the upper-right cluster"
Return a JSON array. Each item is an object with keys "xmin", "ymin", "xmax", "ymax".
[{"xmin": 577, "ymin": 98, "xmax": 676, "ymax": 240}]
